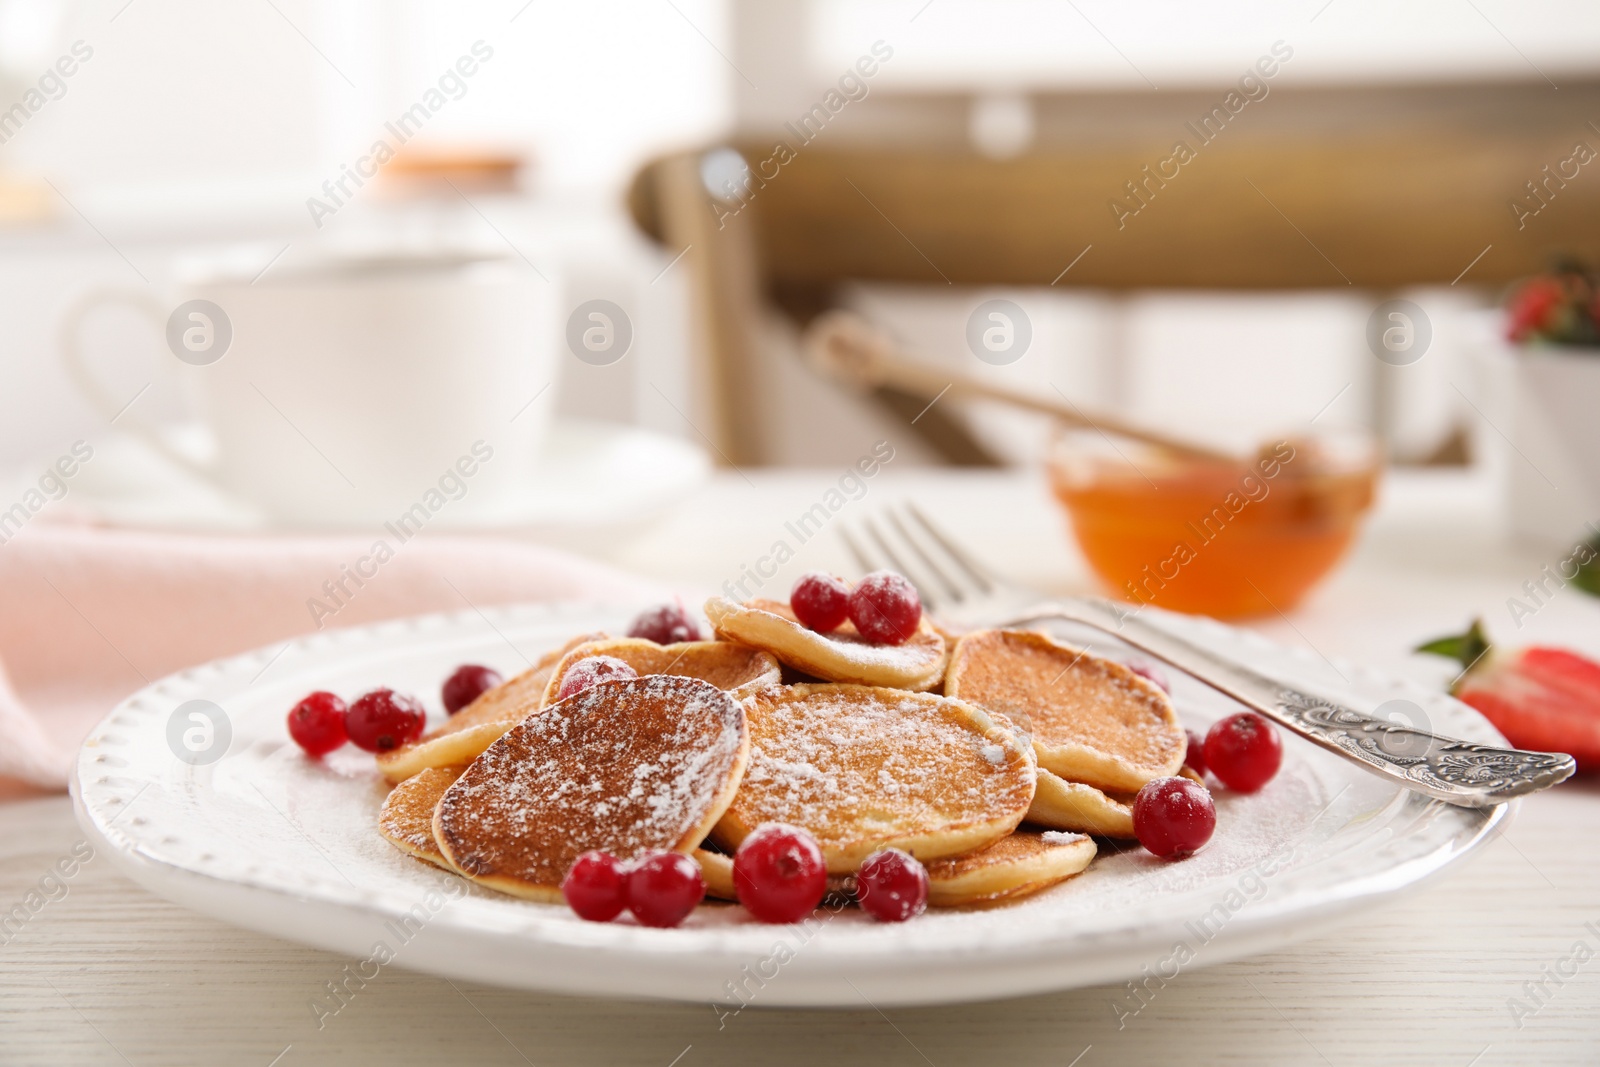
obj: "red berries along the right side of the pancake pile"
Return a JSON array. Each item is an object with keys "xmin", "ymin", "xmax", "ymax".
[{"xmin": 1128, "ymin": 662, "xmax": 1283, "ymax": 859}]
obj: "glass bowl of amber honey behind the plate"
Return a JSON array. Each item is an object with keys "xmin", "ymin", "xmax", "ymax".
[{"xmin": 1050, "ymin": 430, "xmax": 1381, "ymax": 619}]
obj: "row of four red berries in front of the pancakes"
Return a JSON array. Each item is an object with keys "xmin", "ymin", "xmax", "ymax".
[{"xmin": 562, "ymin": 822, "xmax": 928, "ymax": 926}]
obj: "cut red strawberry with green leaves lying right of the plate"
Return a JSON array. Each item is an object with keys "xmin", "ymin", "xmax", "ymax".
[{"xmin": 1416, "ymin": 622, "xmax": 1600, "ymax": 771}]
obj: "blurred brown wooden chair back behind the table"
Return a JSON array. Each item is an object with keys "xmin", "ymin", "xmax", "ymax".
[{"xmin": 630, "ymin": 106, "xmax": 1600, "ymax": 464}]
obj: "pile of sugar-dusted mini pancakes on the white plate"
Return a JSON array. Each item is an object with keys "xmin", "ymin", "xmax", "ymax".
[{"xmin": 378, "ymin": 597, "xmax": 1186, "ymax": 907}]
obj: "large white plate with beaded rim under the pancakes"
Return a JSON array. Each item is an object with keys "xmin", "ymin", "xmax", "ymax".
[{"xmin": 74, "ymin": 605, "xmax": 1509, "ymax": 1011}]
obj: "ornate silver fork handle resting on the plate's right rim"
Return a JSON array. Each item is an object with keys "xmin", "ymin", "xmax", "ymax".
[{"xmin": 1010, "ymin": 598, "xmax": 1578, "ymax": 808}]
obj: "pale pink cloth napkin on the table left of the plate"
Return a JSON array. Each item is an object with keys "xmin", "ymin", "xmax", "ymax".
[{"xmin": 0, "ymin": 525, "xmax": 667, "ymax": 798}]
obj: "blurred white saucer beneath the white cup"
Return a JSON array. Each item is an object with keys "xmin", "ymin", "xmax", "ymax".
[{"xmin": 58, "ymin": 419, "xmax": 710, "ymax": 541}]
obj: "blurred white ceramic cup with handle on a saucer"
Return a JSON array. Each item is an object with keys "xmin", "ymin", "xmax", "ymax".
[{"xmin": 61, "ymin": 254, "xmax": 558, "ymax": 526}]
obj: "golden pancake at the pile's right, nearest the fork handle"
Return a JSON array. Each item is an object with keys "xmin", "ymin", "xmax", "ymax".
[{"xmin": 944, "ymin": 630, "xmax": 1186, "ymax": 793}]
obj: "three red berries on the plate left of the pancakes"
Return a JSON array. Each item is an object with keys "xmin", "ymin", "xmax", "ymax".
[{"xmin": 290, "ymin": 664, "xmax": 504, "ymax": 758}]
